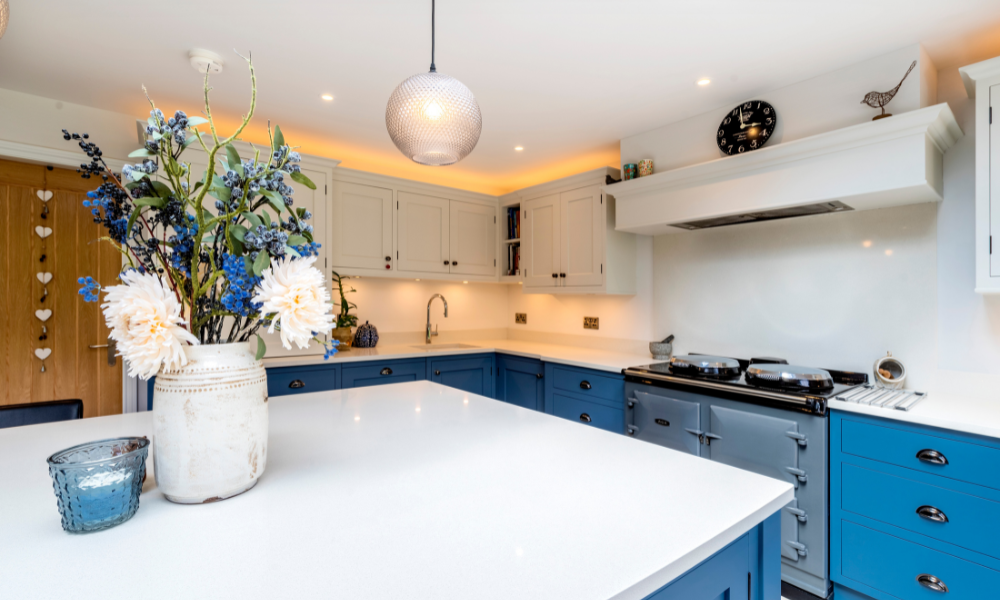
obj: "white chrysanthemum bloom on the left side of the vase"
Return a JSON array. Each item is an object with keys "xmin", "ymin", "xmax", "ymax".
[{"xmin": 101, "ymin": 271, "xmax": 198, "ymax": 379}]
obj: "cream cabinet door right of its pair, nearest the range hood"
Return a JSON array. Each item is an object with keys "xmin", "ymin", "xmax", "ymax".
[{"xmin": 559, "ymin": 187, "xmax": 604, "ymax": 287}]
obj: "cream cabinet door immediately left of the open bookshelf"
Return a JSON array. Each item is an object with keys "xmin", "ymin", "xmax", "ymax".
[{"xmin": 449, "ymin": 200, "xmax": 497, "ymax": 275}]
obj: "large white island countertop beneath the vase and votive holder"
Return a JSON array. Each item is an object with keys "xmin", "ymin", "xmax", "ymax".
[{"xmin": 0, "ymin": 381, "xmax": 793, "ymax": 600}]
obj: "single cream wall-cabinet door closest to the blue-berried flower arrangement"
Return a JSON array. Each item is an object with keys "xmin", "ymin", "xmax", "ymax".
[{"xmin": 330, "ymin": 181, "xmax": 395, "ymax": 270}]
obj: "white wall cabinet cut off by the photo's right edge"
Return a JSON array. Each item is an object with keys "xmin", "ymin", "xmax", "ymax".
[{"xmin": 958, "ymin": 56, "xmax": 1000, "ymax": 294}]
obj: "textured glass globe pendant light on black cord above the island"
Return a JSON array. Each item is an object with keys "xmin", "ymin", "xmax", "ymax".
[{"xmin": 384, "ymin": 0, "xmax": 483, "ymax": 166}]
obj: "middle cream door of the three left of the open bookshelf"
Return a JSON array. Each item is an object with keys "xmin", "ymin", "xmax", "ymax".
[{"xmin": 396, "ymin": 192, "xmax": 451, "ymax": 273}]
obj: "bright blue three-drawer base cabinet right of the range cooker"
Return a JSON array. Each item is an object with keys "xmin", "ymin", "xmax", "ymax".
[{"xmin": 830, "ymin": 410, "xmax": 1000, "ymax": 600}]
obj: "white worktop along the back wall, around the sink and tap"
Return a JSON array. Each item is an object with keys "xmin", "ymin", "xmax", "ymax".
[{"xmin": 264, "ymin": 340, "xmax": 656, "ymax": 373}]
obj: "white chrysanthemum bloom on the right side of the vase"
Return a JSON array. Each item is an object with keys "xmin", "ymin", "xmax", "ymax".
[{"xmin": 253, "ymin": 256, "xmax": 333, "ymax": 350}]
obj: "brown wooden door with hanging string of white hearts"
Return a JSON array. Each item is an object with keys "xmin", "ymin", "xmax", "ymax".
[{"xmin": 0, "ymin": 160, "xmax": 122, "ymax": 417}]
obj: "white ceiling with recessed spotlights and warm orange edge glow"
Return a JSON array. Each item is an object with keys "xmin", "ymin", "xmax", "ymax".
[{"xmin": 0, "ymin": 0, "xmax": 1000, "ymax": 193}]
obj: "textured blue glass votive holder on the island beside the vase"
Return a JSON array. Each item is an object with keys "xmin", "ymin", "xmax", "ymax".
[{"xmin": 48, "ymin": 437, "xmax": 149, "ymax": 533}]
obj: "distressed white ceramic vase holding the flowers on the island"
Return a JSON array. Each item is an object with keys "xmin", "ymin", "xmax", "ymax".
[{"xmin": 153, "ymin": 343, "xmax": 267, "ymax": 504}]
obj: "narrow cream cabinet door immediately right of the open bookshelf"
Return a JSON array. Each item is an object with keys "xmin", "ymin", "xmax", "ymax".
[{"xmin": 521, "ymin": 194, "xmax": 560, "ymax": 287}]
